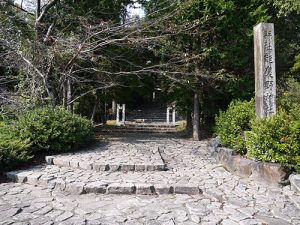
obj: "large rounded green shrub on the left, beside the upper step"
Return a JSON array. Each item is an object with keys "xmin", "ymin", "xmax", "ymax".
[{"xmin": 15, "ymin": 107, "xmax": 92, "ymax": 152}]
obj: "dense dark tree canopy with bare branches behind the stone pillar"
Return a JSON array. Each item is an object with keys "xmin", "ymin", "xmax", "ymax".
[{"xmin": 0, "ymin": 0, "xmax": 300, "ymax": 134}]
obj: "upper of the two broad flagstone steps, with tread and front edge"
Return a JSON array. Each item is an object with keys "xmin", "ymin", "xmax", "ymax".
[{"xmin": 46, "ymin": 142, "xmax": 167, "ymax": 172}]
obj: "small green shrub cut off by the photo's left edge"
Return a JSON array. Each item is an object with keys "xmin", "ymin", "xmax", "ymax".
[{"xmin": 0, "ymin": 124, "xmax": 32, "ymax": 172}]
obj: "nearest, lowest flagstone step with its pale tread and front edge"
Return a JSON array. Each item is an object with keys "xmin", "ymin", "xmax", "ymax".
[{"xmin": 6, "ymin": 165, "xmax": 202, "ymax": 195}]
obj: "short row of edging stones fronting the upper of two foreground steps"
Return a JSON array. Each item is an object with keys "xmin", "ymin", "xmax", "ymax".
[{"xmin": 46, "ymin": 156, "xmax": 167, "ymax": 172}]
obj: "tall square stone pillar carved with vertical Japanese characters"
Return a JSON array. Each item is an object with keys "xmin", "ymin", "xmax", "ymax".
[{"xmin": 254, "ymin": 23, "xmax": 276, "ymax": 118}]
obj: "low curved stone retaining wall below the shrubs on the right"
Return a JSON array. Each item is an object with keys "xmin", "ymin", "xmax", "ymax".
[{"xmin": 209, "ymin": 139, "xmax": 292, "ymax": 186}]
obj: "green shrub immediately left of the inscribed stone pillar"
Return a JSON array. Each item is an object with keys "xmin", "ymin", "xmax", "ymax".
[{"xmin": 215, "ymin": 100, "xmax": 255, "ymax": 154}]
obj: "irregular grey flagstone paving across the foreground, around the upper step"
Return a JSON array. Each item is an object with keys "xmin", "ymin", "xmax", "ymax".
[{"xmin": 0, "ymin": 134, "xmax": 300, "ymax": 225}]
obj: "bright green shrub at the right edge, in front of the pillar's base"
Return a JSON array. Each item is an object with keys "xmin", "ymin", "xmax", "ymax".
[{"xmin": 246, "ymin": 108, "xmax": 300, "ymax": 171}]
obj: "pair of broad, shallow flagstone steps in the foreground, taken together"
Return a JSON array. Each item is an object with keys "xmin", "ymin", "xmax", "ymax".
[{"xmin": 6, "ymin": 140, "xmax": 202, "ymax": 195}]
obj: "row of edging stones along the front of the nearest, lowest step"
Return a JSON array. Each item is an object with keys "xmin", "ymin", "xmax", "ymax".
[{"xmin": 6, "ymin": 171, "xmax": 203, "ymax": 195}]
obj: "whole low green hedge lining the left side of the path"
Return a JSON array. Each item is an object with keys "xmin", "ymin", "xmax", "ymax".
[{"xmin": 0, "ymin": 107, "xmax": 93, "ymax": 172}]
